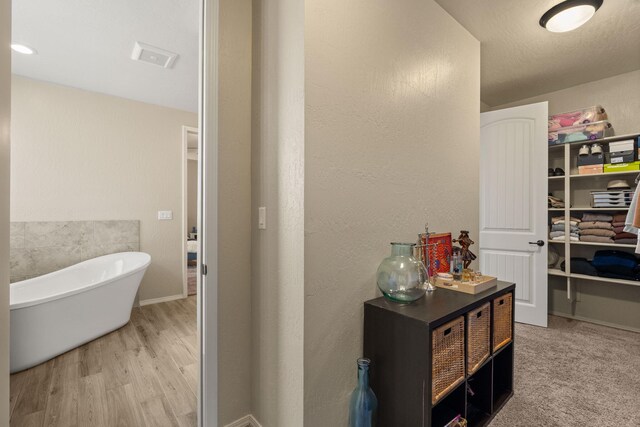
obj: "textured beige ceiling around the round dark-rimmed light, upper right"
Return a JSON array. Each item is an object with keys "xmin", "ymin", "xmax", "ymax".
[{"xmin": 436, "ymin": 0, "xmax": 640, "ymax": 106}]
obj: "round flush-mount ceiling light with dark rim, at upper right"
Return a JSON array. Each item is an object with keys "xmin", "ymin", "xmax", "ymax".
[{"xmin": 540, "ymin": 0, "xmax": 603, "ymax": 33}]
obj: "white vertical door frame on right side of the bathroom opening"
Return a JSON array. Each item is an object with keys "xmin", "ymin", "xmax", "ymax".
[{"xmin": 199, "ymin": 0, "xmax": 220, "ymax": 427}]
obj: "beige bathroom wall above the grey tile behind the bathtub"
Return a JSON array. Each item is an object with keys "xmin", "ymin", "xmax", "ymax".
[{"xmin": 11, "ymin": 76, "xmax": 197, "ymax": 300}]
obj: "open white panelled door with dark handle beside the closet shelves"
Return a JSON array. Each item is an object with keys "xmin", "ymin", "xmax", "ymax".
[{"xmin": 480, "ymin": 102, "xmax": 548, "ymax": 327}]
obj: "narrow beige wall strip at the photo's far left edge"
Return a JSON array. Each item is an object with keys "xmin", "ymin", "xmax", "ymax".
[{"xmin": 0, "ymin": 0, "xmax": 11, "ymax": 426}]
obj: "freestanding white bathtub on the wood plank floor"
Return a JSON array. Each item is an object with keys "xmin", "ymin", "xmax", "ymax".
[{"xmin": 10, "ymin": 252, "xmax": 151, "ymax": 373}]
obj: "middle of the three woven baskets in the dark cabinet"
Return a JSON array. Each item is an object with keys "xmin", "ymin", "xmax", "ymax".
[{"xmin": 467, "ymin": 303, "xmax": 491, "ymax": 375}]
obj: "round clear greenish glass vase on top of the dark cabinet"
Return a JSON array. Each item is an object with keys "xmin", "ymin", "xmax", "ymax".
[{"xmin": 376, "ymin": 243, "xmax": 427, "ymax": 304}]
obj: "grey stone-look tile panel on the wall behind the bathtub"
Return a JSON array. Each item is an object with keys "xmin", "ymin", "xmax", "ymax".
[{"xmin": 10, "ymin": 221, "xmax": 140, "ymax": 282}]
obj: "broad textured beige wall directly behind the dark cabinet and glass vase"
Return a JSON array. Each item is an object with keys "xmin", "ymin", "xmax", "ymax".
[{"xmin": 304, "ymin": 0, "xmax": 480, "ymax": 427}]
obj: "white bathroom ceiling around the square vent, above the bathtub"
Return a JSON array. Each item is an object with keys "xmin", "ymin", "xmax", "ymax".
[{"xmin": 12, "ymin": 0, "xmax": 199, "ymax": 111}]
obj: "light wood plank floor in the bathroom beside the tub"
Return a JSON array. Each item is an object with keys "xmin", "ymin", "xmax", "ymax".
[{"xmin": 10, "ymin": 296, "xmax": 198, "ymax": 427}]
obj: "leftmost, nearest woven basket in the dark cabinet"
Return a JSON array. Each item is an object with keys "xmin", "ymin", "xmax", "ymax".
[{"xmin": 431, "ymin": 316, "xmax": 464, "ymax": 404}]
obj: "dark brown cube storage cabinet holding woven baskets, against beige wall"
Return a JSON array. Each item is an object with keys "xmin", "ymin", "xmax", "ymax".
[{"xmin": 364, "ymin": 282, "xmax": 515, "ymax": 427}]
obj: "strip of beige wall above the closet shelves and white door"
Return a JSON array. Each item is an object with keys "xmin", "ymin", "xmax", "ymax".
[{"xmin": 491, "ymin": 70, "xmax": 640, "ymax": 135}]
